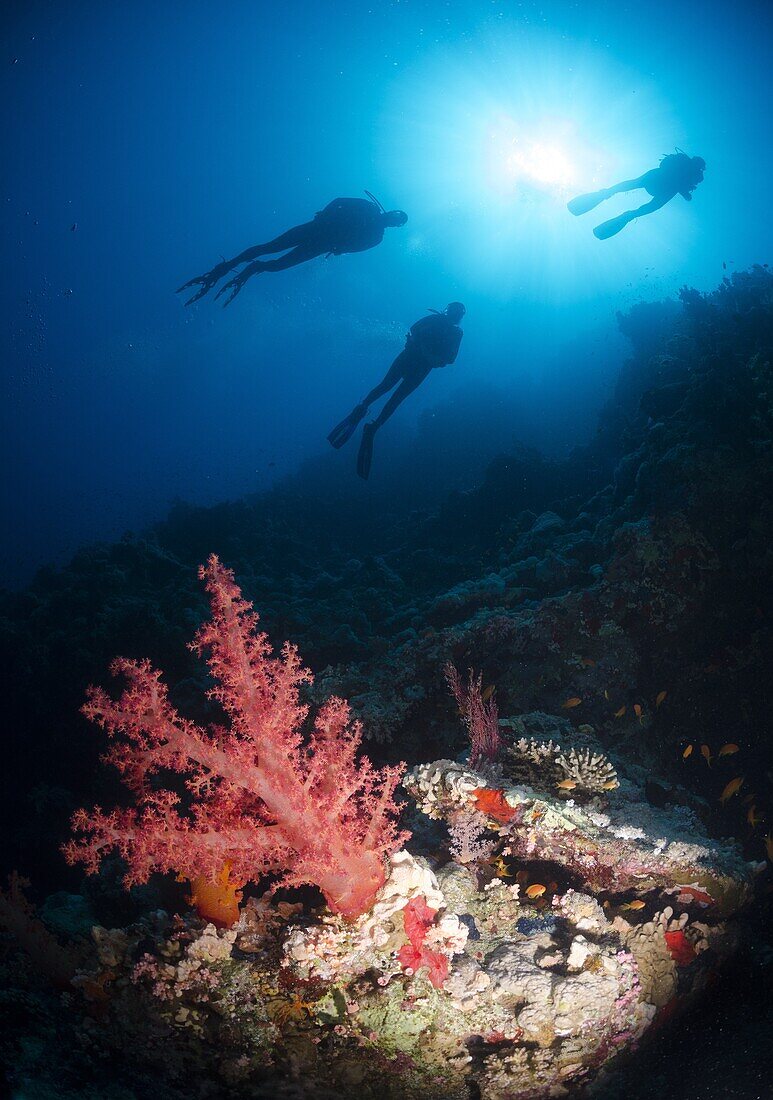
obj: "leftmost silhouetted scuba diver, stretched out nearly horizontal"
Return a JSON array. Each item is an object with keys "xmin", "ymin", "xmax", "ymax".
[{"xmin": 176, "ymin": 191, "xmax": 408, "ymax": 306}]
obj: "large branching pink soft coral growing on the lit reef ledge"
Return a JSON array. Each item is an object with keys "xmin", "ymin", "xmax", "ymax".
[{"xmin": 64, "ymin": 556, "xmax": 409, "ymax": 917}]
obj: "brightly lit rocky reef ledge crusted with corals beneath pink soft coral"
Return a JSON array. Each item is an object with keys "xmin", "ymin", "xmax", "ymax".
[{"xmin": 7, "ymin": 713, "xmax": 754, "ymax": 1100}]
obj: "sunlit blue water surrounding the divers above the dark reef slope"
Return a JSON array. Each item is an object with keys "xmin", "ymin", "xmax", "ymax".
[{"xmin": 0, "ymin": 0, "xmax": 773, "ymax": 585}]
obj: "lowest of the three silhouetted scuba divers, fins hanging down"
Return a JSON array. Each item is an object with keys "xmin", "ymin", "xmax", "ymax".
[{"xmin": 328, "ymin": 301, "xmax": 466, "ymax": 480}]
